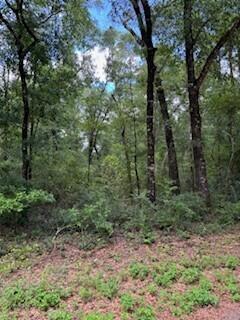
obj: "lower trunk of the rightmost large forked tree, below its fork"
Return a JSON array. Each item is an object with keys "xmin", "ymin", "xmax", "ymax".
[{"xmin": 188, "ymin": 85, "xmax": 210, "ymax": 205}]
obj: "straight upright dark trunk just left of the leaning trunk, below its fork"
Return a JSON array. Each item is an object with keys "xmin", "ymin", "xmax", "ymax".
[{"xmin": 146, "ymin": 47, "xmax": 156, "ymax": 202}]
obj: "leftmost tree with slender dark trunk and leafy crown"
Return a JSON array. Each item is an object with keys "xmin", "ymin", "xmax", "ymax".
[{"xmin": 0, "ymin": 0, "xmax": 92, "ymax": 182}]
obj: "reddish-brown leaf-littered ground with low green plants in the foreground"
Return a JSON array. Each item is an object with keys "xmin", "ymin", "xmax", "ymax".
[{"xmin": 0, "ymin": 227, "xmax": 240, "ymax": 320}]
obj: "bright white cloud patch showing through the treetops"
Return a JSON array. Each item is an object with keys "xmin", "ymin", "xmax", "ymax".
[{"xmin": 77, "ymin": 46, "xmax": 109, "ymax": 82}]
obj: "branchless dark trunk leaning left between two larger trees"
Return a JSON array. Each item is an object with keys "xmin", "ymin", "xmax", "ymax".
[{"xmin": 156, "ymin": 75, "xmax": 180, "ymax": 194}]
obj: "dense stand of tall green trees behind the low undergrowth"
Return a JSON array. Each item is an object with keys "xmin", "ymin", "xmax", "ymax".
[{"xmin": 0, "ymin": 0, "xmax": 240, "ymax": 229}]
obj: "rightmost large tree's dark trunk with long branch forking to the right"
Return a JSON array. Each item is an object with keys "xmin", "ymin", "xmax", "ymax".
[{"xmin": 184, "ymin": 0, "xmax": 240, "ymax": 205}]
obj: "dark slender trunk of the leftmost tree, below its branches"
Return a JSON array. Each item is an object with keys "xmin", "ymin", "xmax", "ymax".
[{"xmin": 18, "ymin": 53, "xmax": 30, "ymax": 181}]
